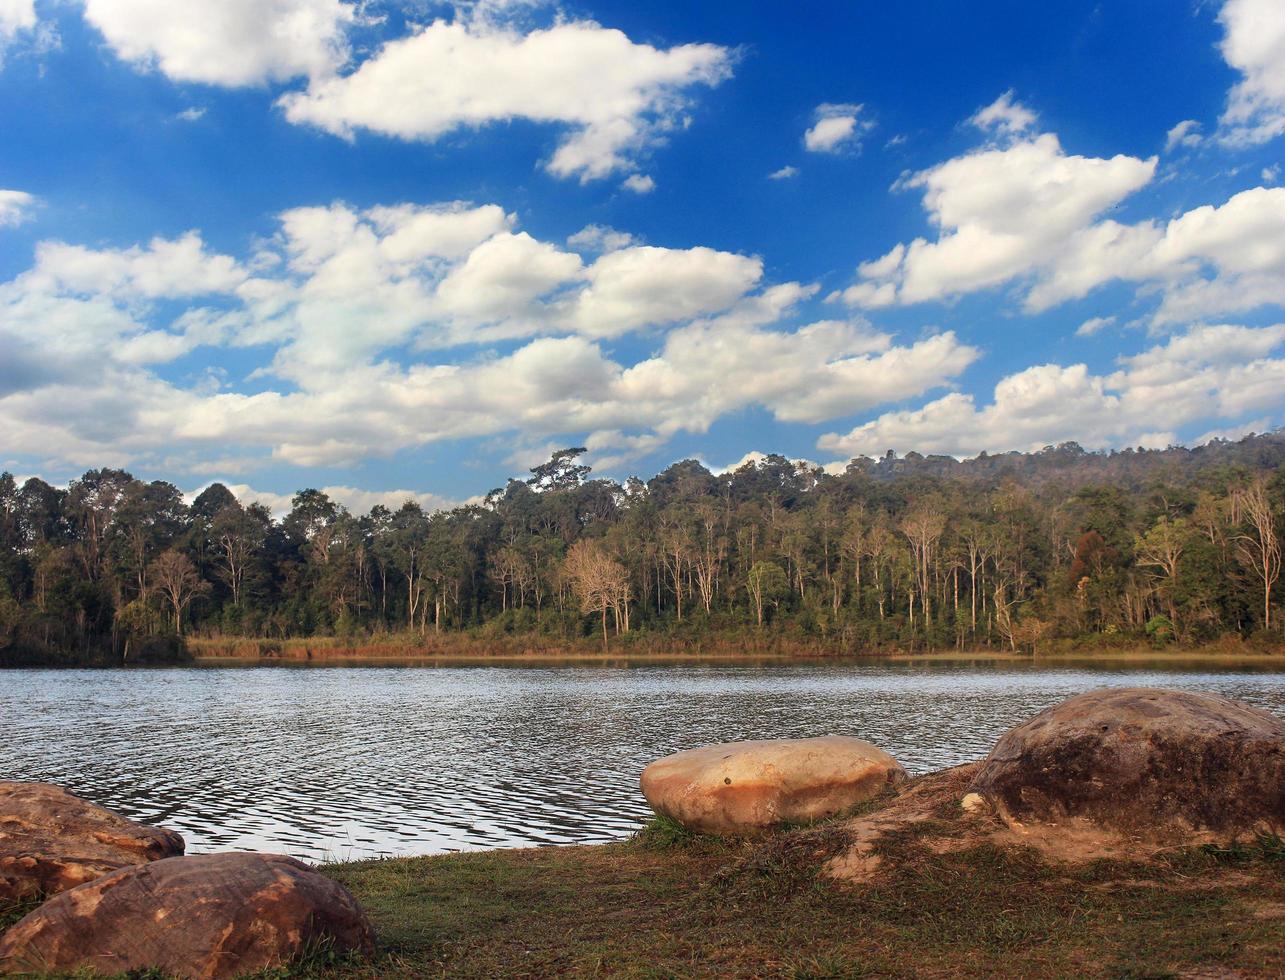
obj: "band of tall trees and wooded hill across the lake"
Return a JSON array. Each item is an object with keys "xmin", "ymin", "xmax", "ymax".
[{"xmin": 0, "ymin": 432, "xmax": 1285, "ymax": 663}]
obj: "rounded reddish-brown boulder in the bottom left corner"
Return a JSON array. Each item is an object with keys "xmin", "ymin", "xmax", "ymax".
[{"xmin": 0, "ymin": 854, "xmax": 374, "ymax": 980}]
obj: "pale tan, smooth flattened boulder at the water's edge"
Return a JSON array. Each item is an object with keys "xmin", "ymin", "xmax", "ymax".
[{"xmin": 641, "ymin": 735, "xmax": 906, "ymax": 835}]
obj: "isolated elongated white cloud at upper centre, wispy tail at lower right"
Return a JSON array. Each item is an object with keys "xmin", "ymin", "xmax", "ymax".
[{"xmin": 280, "ymin": 21, "xmax": 732, "ymax": 181}]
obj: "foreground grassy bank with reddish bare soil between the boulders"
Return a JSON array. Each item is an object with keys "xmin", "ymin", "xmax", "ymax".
[{"xmin": 310, "ymin": 786, "xmax": 1285, "ymax": 977}]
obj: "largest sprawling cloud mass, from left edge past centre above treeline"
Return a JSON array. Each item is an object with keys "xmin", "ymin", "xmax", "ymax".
[{"xmin": 0, "ymin": 203, "xmax": 978, "ymax": 475}]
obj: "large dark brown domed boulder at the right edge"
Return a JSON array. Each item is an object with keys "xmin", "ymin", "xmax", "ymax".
[{"xmin": 970, "ymin": 687, "xmax": 1285, "ymax": 840}]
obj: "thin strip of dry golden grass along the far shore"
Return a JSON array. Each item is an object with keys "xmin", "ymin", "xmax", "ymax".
[{"xmin": 186, "ymin": 633, "xmax": 1285, "ymax": 663}]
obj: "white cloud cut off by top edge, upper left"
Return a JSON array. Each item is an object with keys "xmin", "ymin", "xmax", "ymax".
[{"xmin": 84, "ymin": 0, "xmax": 357, "ymax": 86}]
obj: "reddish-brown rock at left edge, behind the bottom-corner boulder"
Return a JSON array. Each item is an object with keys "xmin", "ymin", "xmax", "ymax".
[{"xmin": 0, "ymin": 782, "xmax": 182, "ymax": 902}]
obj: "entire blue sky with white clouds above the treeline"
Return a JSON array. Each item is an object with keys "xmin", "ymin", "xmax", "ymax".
[{"xmin": 0, "ymin": 0, "xmax": 1285, "ymax": 509}]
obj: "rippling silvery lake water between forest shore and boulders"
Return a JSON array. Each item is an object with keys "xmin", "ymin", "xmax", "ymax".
[{"xmin": 0, "ymin": 661, "xmax": 1285, "ymax": 861}]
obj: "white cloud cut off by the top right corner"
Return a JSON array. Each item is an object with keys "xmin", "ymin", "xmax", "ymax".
[{"xmin": 1218, "ymin": 0, "xmax": 1285, "ymax": 145}]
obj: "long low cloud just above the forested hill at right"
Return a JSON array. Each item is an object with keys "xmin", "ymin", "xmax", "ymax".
[{"xmin": 817, "ymin": 324, "xmax": 1285, "ymax": 456}]
